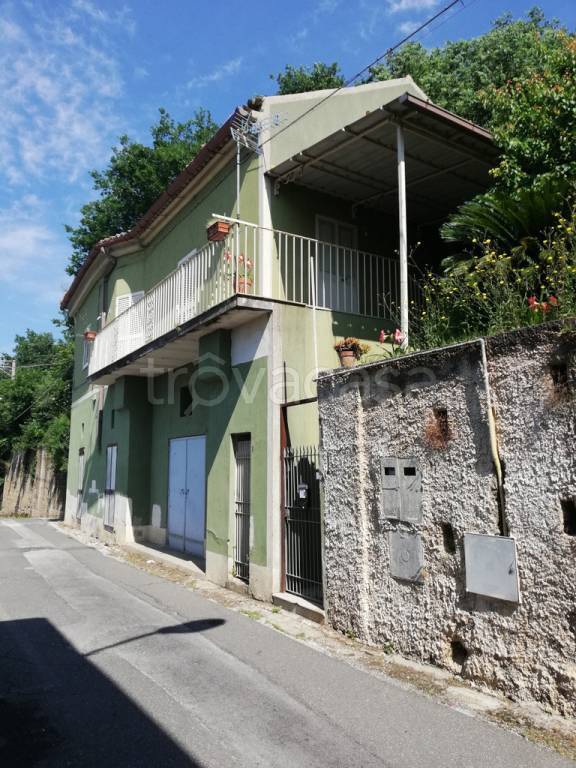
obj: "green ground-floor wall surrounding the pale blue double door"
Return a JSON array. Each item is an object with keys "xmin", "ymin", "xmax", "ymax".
[{"xmin": 149, "ymin": 331, "xmax": 267, "ymax": 565}]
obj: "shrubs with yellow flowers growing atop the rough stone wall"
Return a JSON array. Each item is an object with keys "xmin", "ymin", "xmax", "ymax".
[{"xmin": 411, "ymin": 207, "xmax": 576, "ymax": 349}]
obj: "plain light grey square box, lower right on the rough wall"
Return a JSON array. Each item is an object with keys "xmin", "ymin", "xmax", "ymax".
[{"xmin": 464, "ymin": 533, "xmax": 520, "ymax": 603}]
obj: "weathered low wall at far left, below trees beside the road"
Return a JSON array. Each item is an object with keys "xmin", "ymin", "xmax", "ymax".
[{"xmin": 0, "ymin": 448, "xmax": 66, "ymax": 520}]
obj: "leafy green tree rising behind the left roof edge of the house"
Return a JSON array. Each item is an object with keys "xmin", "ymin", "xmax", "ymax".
[{"xmin": 66, "ymin": 109, "xmax": 218, "ymax": 275}]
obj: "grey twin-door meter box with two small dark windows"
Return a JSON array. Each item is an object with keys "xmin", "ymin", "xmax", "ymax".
[{"xmin": 380, "ymin": 456, "xmax": 422, "ymax": 524}]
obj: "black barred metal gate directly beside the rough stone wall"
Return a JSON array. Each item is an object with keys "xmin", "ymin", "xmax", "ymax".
[{"xmin": 284, "ymin": 446, "xmax": 323, "ymax": 605}]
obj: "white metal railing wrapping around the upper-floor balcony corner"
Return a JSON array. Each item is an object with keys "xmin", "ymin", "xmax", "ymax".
[{"xmin": 88, "ymin": 220, "xmax": 419, "ymax": 375}]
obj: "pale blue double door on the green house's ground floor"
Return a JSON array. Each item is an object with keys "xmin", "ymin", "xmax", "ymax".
[{"xmin": 168, "ymin": 436, "xmax": 206, "ymax": 557}]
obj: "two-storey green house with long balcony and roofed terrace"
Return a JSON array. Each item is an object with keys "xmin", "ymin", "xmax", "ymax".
[{"xmin": 62, "ymin": 78, "xmax": 496, "ymax": 602}]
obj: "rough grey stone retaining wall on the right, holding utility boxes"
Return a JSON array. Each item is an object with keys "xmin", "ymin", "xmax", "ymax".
[{"xmin": 318, "ymin": 324, "xmax": 576, "ymax": 715}]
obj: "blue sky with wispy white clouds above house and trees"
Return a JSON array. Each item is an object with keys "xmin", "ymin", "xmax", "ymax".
[{"xmin": 0, "ymin": 0, "xmax": 576, "ymax": 352}]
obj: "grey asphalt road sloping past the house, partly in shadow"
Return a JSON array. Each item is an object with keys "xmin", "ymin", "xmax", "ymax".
[{"xmin": 0, "ymin": 521, "xmax": 574, "ymax": 768}]
